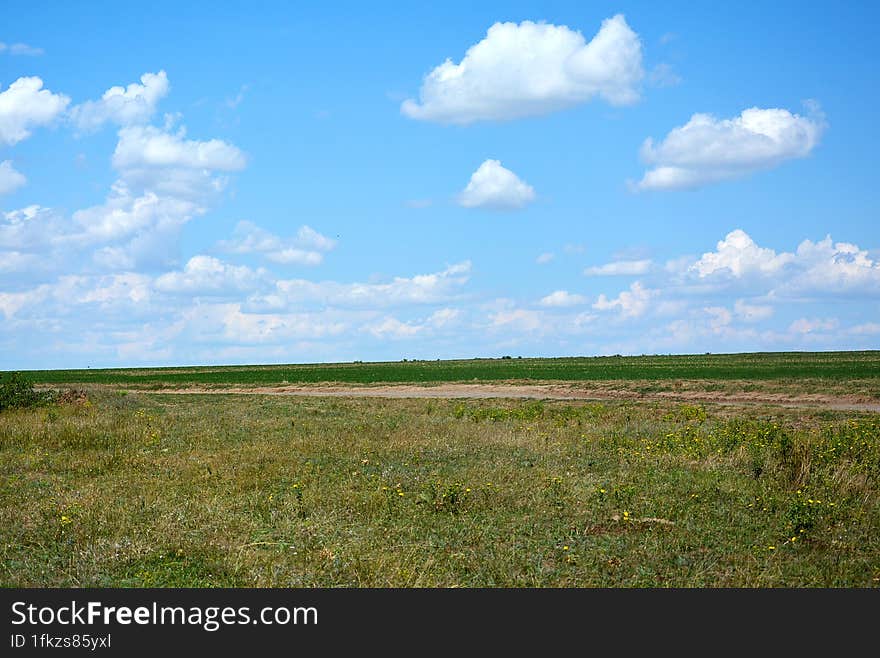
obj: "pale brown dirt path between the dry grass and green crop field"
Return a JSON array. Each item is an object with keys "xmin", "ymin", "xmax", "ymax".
[{"xmin": 138, "ymin": 384, "xmax": 880, "ymax": 413}]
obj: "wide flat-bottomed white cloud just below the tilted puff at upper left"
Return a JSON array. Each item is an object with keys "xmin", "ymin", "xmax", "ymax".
[{"xmin": 113, "ymin": 126, "xmax": 245, "ymax": 171}]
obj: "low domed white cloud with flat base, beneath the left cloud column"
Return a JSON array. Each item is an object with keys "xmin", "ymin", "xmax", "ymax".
[{"xmin": 155, "ymin": 255, "xmax": 266, "ymax": 295}]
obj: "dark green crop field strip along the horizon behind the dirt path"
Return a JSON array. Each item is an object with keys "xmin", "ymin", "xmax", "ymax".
[{"xmin": 8, "ymin": 350, "xmax": 880, "ymax": 387}]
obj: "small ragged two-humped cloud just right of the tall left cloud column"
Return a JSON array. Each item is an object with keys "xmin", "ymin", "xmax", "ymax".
[{"xmin": 219, "ymin": 220, "xmax": 336, "ymax": 265}]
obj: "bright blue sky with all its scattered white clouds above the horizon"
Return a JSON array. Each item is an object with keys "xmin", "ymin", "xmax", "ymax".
[{"xmin": 0, "ymin": 1, "xmax": 880, "ymax": 369}]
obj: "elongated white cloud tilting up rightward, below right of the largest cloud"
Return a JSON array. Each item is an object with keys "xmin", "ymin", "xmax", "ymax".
[{"xmin": 635, "ymin": 107, "xmax": 825, "ymax": 190}]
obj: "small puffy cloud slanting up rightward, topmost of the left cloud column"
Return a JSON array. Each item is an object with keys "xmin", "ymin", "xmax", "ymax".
[{"xmin": 70, "ymin": 71, "xmax": 169, "ymax": 132}]
